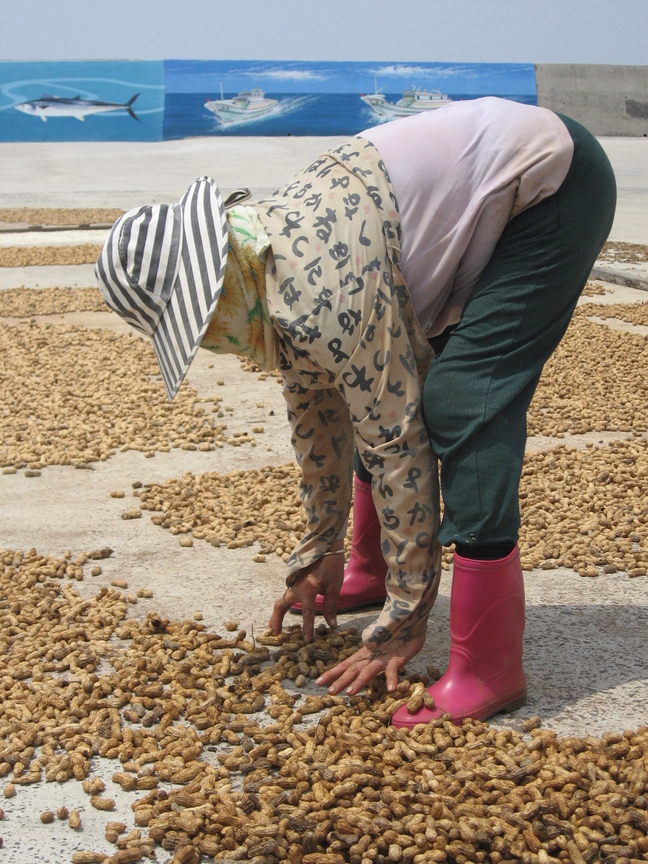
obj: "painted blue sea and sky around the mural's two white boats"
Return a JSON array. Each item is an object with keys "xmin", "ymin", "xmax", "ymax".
[{"xmin": 164, "ymin": 60, "xmax": 536, "ymax": 138}]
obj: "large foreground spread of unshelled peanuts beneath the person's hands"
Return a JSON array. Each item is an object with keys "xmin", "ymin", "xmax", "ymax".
[{"xmin": 0, "ymin": 550, "xmax": 648, "ymax": 864}]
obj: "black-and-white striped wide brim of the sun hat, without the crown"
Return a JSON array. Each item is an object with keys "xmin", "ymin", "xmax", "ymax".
[{"xmin": 151, "ymin": 177, "xmax": 227, "ymax": 401}]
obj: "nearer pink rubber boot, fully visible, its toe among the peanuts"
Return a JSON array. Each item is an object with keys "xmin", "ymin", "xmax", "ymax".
[{"xmin": 391, "ymin": 546, "xmax": 526, "ymax": 729}]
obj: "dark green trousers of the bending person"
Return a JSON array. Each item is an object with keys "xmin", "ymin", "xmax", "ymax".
[{"xmin": 355, "ymin": 117, "xmax": 616, "ymax": 548}]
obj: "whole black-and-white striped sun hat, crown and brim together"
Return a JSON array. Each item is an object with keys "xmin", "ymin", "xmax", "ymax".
[{"xmin": 95, "ymin": 177, "xmax": 227, "ymax": 401}]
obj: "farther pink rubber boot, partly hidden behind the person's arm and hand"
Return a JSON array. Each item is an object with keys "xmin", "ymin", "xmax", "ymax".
[{"xmin": 290, "ymin": 477, "xmax": 387, "ymax": 615}]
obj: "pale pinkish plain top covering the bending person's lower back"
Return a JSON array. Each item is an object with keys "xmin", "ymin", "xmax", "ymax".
[{"xmin": 360, "ymin": 97, "xmax": 573, "ymax": 336}]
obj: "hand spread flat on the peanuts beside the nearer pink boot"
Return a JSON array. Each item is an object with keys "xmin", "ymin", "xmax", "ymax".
[{"xmin": 316, "ymin": 633, "xmax": 425, "ymax": 696}]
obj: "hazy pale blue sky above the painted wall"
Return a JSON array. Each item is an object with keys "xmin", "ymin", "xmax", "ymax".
[{"xmin": 0, "ymin": 0, "xmax": 648, "ymax": 65}]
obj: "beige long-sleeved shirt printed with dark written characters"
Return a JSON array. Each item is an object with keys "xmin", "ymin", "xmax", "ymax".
[{"xmin": 255, "ymin": 138, "xmax": 441, "ymax": 652}]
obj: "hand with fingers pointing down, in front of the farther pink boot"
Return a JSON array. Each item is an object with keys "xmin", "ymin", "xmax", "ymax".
[{"xmin": 269, "ymin": 540, "xmax": 344, "ymax": 642}]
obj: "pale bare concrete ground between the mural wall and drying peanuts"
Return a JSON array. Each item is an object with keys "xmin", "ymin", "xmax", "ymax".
[{"xmin": 0, "ymin": 137, "xmax": 648, "ymax": 244}]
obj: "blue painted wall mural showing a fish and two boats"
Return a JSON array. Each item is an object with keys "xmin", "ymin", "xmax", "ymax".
[{"xmin": 0, "ymin": 60, "xmax": 536, "ymax": 141}]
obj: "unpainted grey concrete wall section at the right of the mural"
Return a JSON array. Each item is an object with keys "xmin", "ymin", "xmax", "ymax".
[{"xmin": 535, "ymin": 63, "xmax": 648, "ymax": 136}]
